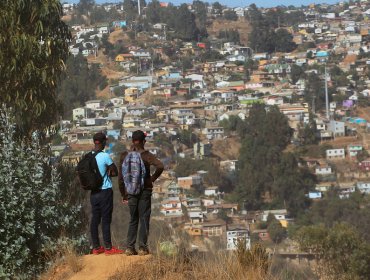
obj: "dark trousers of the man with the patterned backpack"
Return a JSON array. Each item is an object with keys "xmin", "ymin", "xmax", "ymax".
[{"xmin": 127, "ymin": 189, "xmax": 152, "ymax": 249}]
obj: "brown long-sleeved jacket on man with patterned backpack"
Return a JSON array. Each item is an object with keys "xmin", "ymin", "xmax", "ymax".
[{"xmin": 118, "ymin": 149, "xmax": 164, "ymax": 199}]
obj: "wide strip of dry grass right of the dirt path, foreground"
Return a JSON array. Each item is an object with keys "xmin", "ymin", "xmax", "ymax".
[{"xmin": 109, "ymin": 243, "xmax": 273, "ymax": 280}]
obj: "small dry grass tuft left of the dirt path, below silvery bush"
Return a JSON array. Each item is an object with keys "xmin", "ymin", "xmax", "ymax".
[{"xmin": 40, "ymin": 245, "xmax": 83, "ymax": 280}]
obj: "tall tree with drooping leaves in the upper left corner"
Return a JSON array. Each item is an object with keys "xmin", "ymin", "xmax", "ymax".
[{"xmin": 0, "ymin": 0, "xmax": 71, "ymax": 135}]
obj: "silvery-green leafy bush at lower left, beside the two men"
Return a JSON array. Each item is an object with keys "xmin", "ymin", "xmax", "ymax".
[{"xmin": 0, "ymin": 107, "xmax": 86, "ymax": 279}]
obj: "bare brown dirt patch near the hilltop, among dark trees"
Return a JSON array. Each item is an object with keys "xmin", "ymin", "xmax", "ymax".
[{"xmin": 207, "ymin": 19, "xmax": 252, "ymax": 46}]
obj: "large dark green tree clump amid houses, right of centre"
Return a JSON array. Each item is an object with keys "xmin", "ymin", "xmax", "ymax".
[{"xmin": 234, "ymin": 105, "xmax": 315, "ymax": 213}]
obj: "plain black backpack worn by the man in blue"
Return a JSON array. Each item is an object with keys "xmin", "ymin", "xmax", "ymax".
[{"xmin": 76, "ymin": 151, "xmax": 104, "ymax": 191}]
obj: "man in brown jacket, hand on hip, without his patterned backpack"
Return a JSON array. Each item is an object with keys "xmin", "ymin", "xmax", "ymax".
[{"xmin": 118, "ymin": 130, "xmax": 164, "ymax": 256}]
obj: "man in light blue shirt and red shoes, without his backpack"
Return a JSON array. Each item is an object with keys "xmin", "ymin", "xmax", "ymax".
[{"xmin": 90, "ymin": 132, "xmax": 123, "ymax": 255}]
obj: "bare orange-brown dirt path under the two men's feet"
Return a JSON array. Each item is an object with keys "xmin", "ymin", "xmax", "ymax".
[{"xmin": 48, "ymin": 254, "xmax": 150, "ymax": 280}]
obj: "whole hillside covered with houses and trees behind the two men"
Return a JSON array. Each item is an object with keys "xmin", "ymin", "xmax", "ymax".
[{"xmin": 51, "ymin": 0, "xmax": 370, "ymax": 278}]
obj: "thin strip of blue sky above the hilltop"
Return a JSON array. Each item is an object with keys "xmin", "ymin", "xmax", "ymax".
[{"xmin": 67, "ymin": 0, "xmax": 339, "ymax": 7}]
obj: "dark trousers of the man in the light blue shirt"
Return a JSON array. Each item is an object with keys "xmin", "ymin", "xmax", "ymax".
[{"xmin": 90, "ymin": 189, "xmax": 113, "ymax": 249}]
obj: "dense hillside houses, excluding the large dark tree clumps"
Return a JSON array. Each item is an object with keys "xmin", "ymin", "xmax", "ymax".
[{"xmin": 51, "ymin": 1, "xmax": 370, "ymax": 260}]
